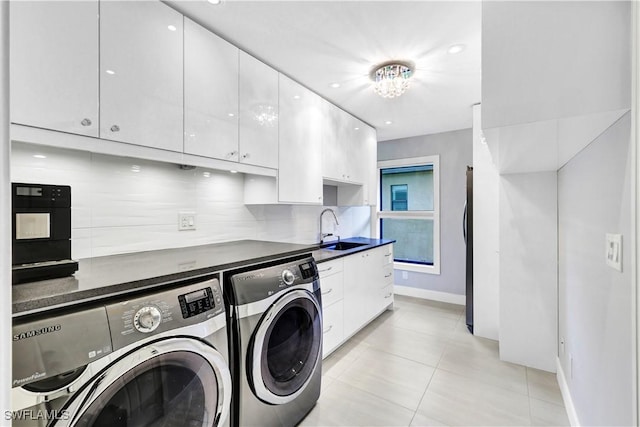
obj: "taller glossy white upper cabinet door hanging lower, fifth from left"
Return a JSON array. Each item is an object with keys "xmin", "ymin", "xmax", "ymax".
[{"xmin": 278, "ymin": 74, "xmax": 326, "ymax": 204}]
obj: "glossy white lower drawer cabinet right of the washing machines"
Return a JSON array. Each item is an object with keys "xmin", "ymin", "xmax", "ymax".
[{"xmin": 318, "ymin": 245, "xmax": 393, "ymax": 357}]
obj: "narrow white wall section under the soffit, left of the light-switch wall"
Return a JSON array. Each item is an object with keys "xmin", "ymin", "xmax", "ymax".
[{"xmin": 499, "ymin": 172, "xmax": 558, "ymax": 372}]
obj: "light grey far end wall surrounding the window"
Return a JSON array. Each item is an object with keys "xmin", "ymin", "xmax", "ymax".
[{"xmin": 378, "ymin": 129, "xmax": 473, "ymax": 301}]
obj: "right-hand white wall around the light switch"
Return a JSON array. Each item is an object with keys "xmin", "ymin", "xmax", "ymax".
[{"xmin": 558, "ymin": 114, "xmax": 636, "ymax": 425}]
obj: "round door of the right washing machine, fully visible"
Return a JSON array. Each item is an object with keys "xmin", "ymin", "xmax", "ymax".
[{"xmin": 247, "ymin": 289, "xmax": 322, "ymax": 404}]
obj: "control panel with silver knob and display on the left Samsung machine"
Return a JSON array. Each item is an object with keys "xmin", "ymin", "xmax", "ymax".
[{"xmin": 106, "ymin": 278, "xmax": 224, "ymax": 350}]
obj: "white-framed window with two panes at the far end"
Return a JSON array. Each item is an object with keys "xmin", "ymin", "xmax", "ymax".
[{"xmin": 378, "ymin": 156, "xmax": 440, "ymax": 274}]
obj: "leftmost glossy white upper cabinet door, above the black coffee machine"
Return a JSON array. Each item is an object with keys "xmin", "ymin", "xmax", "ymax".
[{"xmin": 9, "ymin": 1, "xmax": 98, "ymax": 137}]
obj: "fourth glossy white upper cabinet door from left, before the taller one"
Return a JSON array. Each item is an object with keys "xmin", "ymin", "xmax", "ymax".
[{"xmin": 239, "ymin": 51, "xmax": 279, "ymax": 169}]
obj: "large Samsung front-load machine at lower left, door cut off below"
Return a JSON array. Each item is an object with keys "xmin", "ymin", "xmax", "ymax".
[{"xmin": 10, "ymin": 275, "xmax": 232, "ymax": 427}]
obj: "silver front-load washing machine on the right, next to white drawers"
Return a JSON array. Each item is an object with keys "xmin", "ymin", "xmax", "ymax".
[{"xmin": 223, "ymin": 255, "xmax": 322, "ymax": 426}]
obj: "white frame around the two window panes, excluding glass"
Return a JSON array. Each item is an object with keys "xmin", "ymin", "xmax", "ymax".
[{"xmin": 375, "ymin": 155, "xmax": 440, "ymax": 275}]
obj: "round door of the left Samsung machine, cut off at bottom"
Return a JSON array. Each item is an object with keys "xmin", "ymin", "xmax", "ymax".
[{"xmin": 56, "ymin": 338, "xmax": 231, "ymax": 427}]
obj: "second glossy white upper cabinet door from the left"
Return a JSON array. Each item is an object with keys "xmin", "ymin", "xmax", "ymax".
[{"xmin": 100, "ymin": 1, "xmax": 183, "ymax": 152}]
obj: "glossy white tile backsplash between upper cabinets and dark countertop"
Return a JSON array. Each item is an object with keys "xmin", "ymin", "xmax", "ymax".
[{"xmin": 11, "ymin": 142, "xmax": 370, "ymax": 259}]
